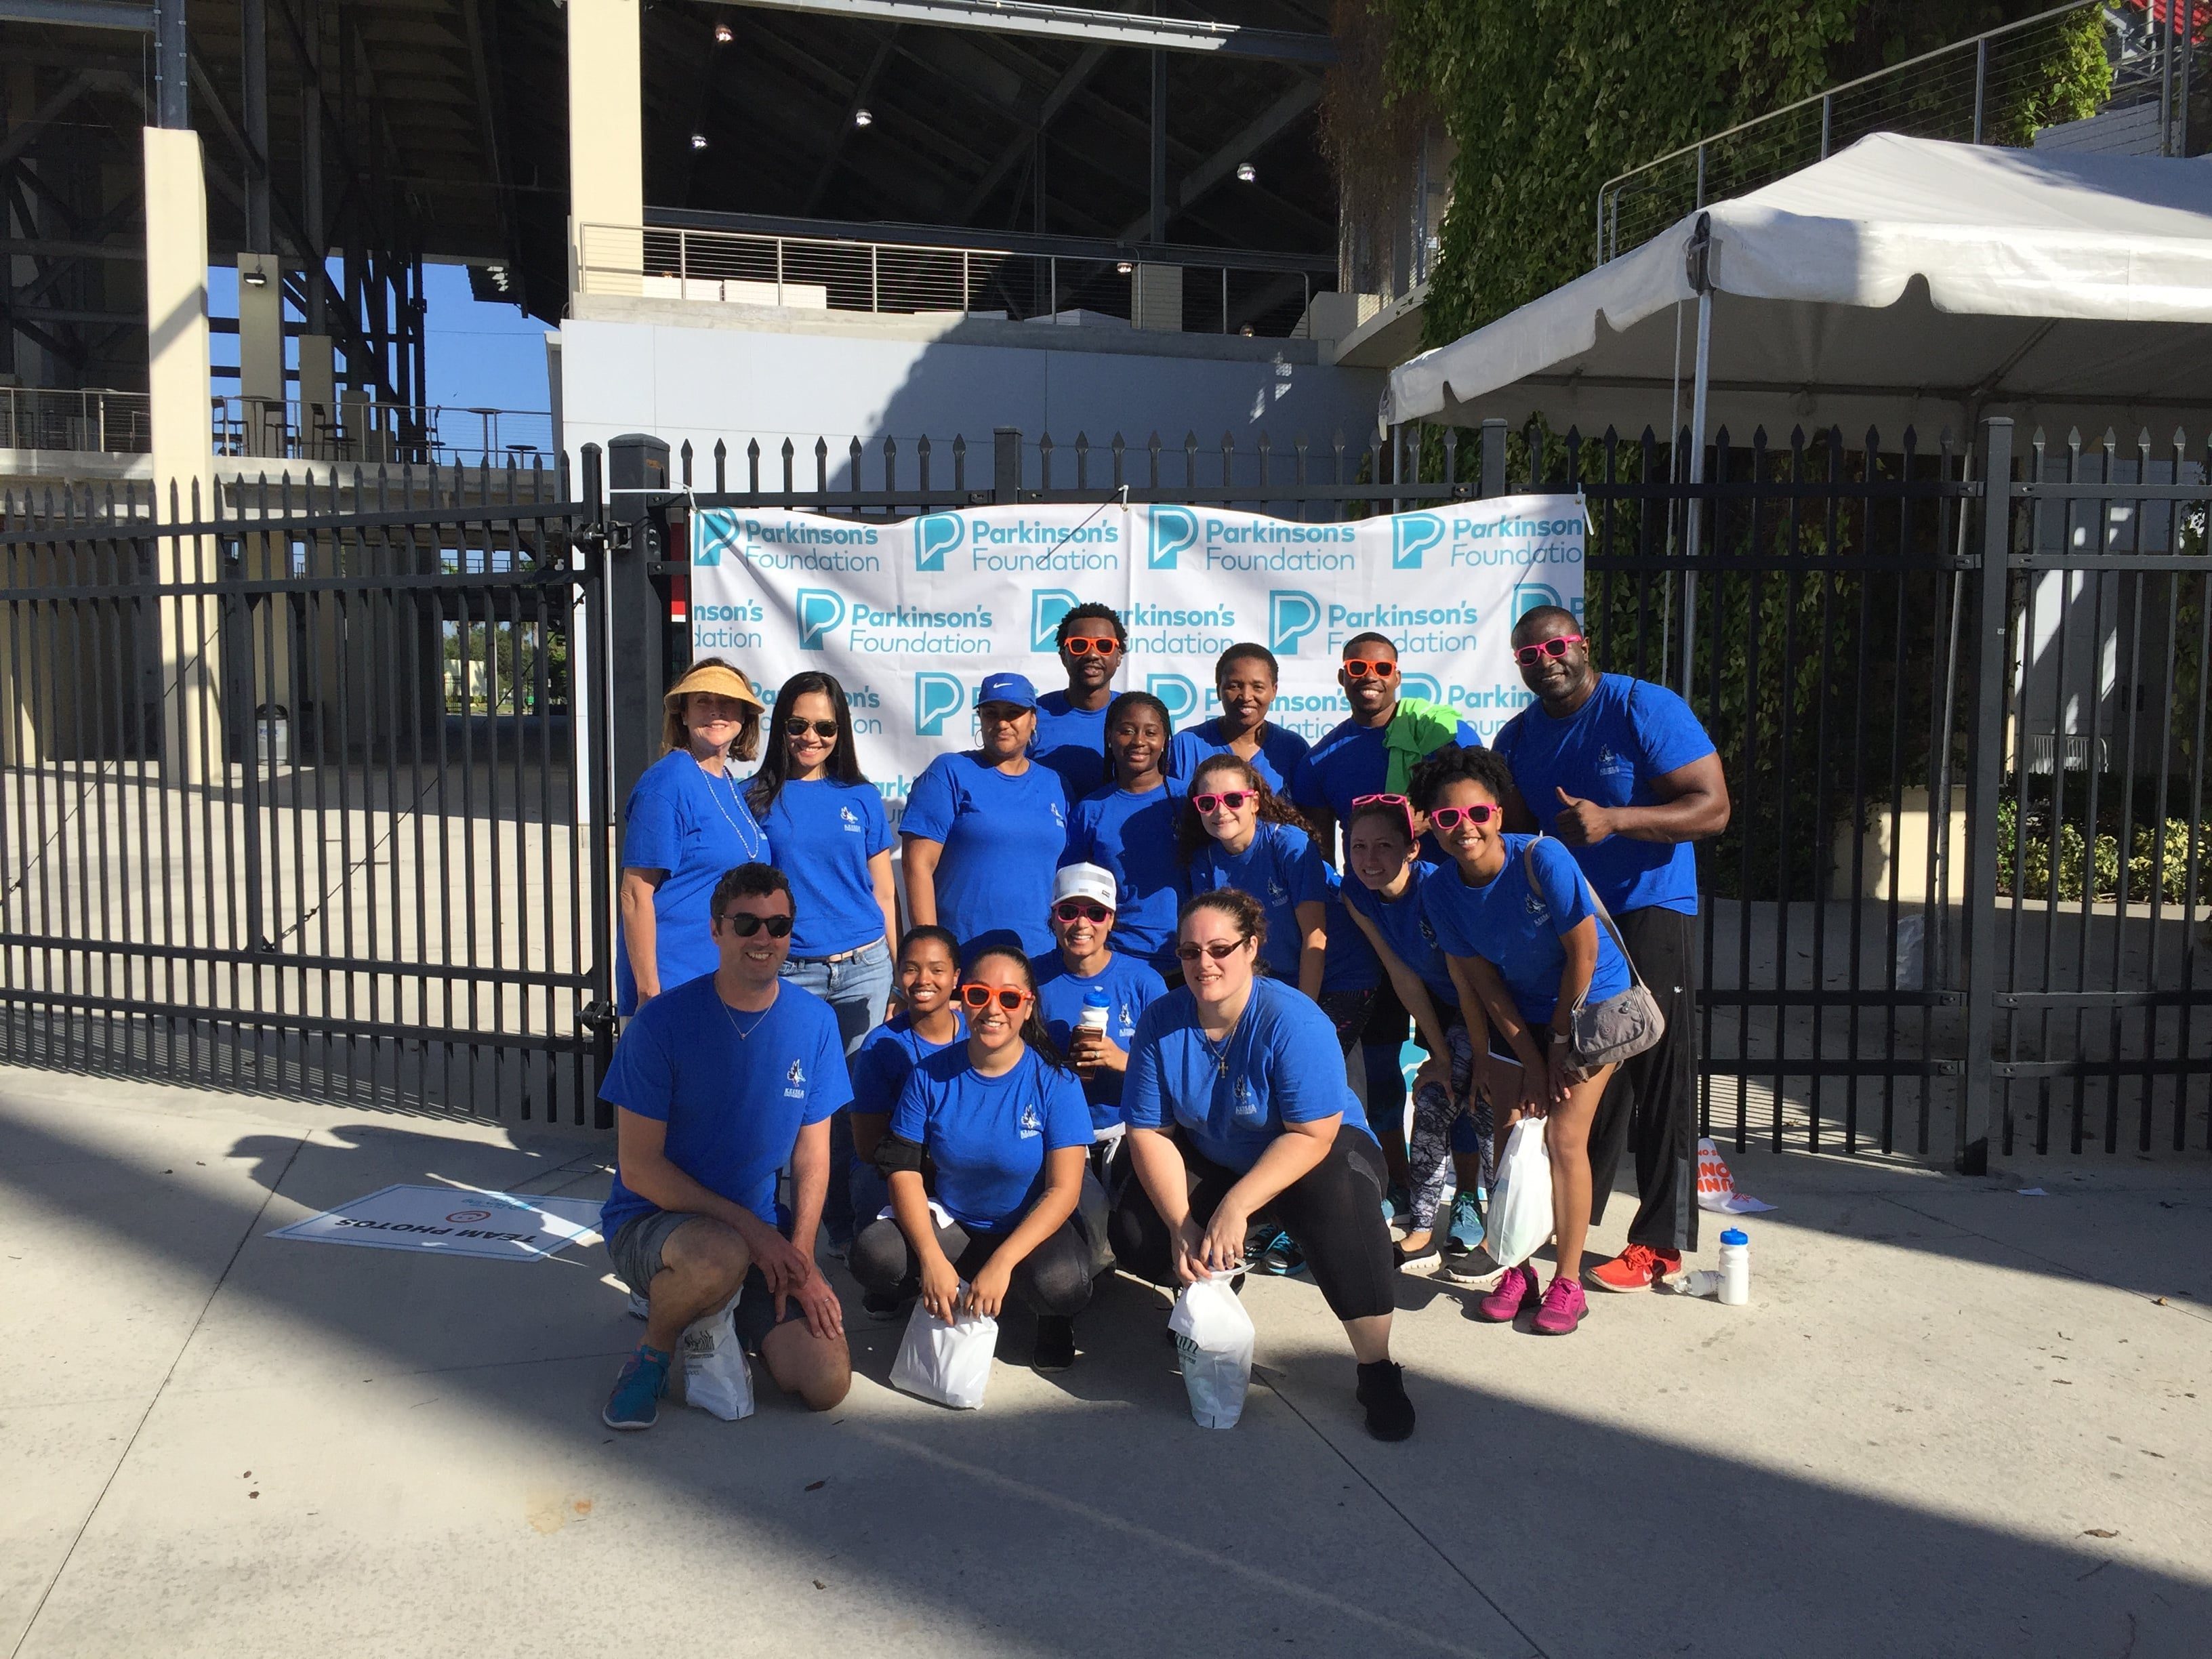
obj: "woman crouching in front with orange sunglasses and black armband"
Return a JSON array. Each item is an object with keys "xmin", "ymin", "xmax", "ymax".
[{"xmin": 852, "ymin": 949, "xmax": 1097, "ymax": 1372}]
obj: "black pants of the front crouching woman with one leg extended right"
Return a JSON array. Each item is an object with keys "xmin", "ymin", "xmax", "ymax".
[{"xmin": 1108, "ymin": 1126, "xmax": 1398, "ymax": 1318}]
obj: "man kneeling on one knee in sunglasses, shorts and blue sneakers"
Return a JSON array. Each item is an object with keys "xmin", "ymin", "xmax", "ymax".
[{"xmin": 600, "ymin": 865, "xmax": 852, "ymax": 1429}]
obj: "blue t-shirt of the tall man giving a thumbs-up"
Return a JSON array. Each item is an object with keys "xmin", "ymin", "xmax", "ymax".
[{"xmin": 1491, "ymin": 675, "xmax": 1715, "ymax": 916}]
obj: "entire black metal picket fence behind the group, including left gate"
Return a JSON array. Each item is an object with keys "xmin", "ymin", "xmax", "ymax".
[{"xmin": 0, "ymin": 422, "xmax": 2212, "ymax": 1170}]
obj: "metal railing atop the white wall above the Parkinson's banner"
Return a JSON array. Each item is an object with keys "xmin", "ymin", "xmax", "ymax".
[{"xmin": 577, "ymin": 226, "xmax": 1334, "ymax": 338}]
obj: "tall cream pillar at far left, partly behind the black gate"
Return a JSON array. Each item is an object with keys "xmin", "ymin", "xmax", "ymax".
[{"xmin": 144, "ymin": 126, "xmax": 224, "ymax": 783}]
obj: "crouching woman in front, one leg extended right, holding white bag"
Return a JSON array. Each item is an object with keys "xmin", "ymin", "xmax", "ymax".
[{"xmin": 1113, "ymin": 887, "xmax": 1414, "ymax": 1440}]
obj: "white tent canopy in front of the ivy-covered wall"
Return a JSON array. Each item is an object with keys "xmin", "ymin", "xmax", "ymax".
[{"xmin": 1382, "ymin": 133, "xmax": 2212, "ymax": 447}]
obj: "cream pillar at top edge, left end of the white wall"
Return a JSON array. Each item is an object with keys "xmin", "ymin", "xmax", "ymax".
[{"xmin": 567, "ymin": 0, "xmax": 646, "ymax": 296}]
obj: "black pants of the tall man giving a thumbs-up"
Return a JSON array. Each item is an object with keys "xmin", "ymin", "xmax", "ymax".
[{"xmin": 1591, "ymin": 907, "xmax": 1699, "ymax": 1250}]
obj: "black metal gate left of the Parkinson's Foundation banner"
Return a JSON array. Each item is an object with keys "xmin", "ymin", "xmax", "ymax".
[{"xmin": 0, "ymin": 469, "xmax": 609, "ymax": 1124}]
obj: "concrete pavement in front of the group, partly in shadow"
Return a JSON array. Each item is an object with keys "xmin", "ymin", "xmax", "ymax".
[{"xmin": 0, "ymin": 1071, "xmax": 2212, "ymax": 1659}]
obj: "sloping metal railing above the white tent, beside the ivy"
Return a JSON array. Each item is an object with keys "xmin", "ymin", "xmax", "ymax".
[{"xmin": 1597, "ymin": 0, "xmax": 2150, "ymax": 266}]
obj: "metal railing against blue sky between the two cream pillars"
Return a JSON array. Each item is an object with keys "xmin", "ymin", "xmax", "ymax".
[{"xmin": 215, "ymin": 396, "xmax": 553, "ymax": 467}]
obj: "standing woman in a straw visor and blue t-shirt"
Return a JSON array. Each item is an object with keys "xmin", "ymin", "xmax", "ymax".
[{"xmin": 615, "ymin": 657, "xmax": 768, "ymax": 1015}]
